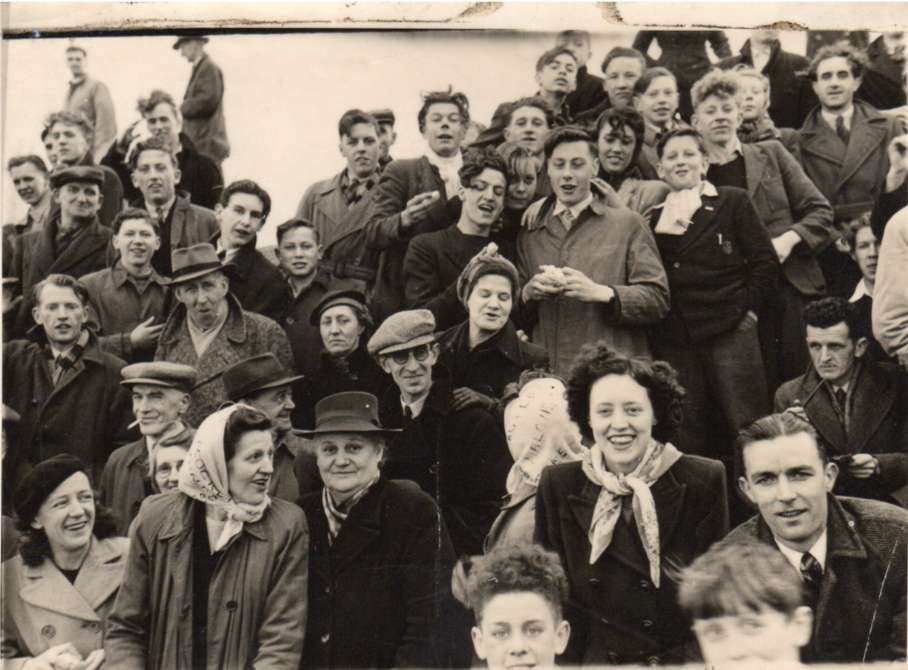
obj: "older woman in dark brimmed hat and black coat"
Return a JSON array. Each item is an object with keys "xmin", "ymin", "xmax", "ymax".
[{"xmin": 299, "ymin": 393, "xmax": 470, "ymax": 668}]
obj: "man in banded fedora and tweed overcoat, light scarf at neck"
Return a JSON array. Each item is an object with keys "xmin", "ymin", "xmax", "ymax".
[{"xmin": 155, "ymin": 244, "xmax": 293, "ymax": 426}]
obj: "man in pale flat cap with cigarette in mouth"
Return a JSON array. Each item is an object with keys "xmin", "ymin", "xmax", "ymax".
[{"xmin": 100, "ymin": 362, "xmax": 197, "ymax": 535}]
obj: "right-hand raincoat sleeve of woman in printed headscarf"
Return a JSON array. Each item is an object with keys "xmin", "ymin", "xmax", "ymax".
[{"xmin": 252, "ymin": 505, "xmax": 309, "ymax": 670}]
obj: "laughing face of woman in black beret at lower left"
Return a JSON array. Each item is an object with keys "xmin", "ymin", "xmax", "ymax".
[{"xmin": 31, "ymin": 472, "xmax": 95, "ymax": 554}]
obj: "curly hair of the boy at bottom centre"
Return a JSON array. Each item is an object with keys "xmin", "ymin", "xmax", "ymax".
[{"xmin": 451, "ymin": 543, "xmax": 569, "ymax": 625}]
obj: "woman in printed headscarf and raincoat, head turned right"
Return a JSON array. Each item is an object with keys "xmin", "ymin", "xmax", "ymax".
[{"xmin": 105, "ymin": 404, "xmax": 309, "ymax": 670}]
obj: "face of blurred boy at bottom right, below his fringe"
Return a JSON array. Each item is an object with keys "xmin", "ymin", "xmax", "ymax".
[{"xmin": 693, "ymin": 607, "xmax": 813, "ymax": 667}]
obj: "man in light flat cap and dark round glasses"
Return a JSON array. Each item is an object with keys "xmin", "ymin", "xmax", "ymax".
[{"xmin": 369, "ymin": 309, "xmax": 514, "ymax": 556}]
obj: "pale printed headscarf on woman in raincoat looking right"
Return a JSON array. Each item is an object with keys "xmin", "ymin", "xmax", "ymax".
[{"xmin": 179, "ymin": 404, "xmax": 271, "ymax": 552}]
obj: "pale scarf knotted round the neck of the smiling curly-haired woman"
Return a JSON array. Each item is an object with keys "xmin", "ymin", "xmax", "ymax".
[{"xmin": 581, "ymin": 439, "xmax": 681, "ymax": 588}]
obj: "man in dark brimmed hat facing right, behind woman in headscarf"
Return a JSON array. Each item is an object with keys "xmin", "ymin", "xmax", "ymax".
[{"xmin": 223, "ymin": 353, "xmax": 322, "ymax": 502}]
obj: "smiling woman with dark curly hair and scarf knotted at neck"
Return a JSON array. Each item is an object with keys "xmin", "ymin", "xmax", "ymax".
[{"xmin": 536, "ymin": 342, "xmax": 728, "ymax": 665}]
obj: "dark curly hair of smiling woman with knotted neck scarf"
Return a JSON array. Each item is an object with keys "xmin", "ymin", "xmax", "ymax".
[{"xmin": 566, "ymin": 341, "xmax": 685, "ymax": 442}]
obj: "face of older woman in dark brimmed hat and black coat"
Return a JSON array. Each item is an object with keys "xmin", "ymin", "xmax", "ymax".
[{"xmin": 315, "ymin": 433, "xmax": 384, "ymax": 503}]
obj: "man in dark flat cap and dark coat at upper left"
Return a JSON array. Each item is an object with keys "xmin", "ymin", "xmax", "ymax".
[{"xmin": 10, "ymin": 166, "xmax": 112, "ymax": 337}]
